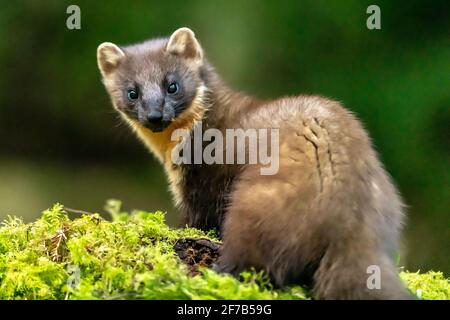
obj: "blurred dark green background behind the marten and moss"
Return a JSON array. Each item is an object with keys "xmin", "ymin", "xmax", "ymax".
[{"xmin": 0, "ymin": 0, "xmax": 450, "ymax": 275}]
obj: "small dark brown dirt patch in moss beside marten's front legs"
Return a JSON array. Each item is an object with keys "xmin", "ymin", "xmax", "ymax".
[{"xmin": 174, "ymin": 238, "xmax": 222, "ymax": 276}]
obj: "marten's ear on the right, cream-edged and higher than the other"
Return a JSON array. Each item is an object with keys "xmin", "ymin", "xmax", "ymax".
[{"xmin": 166, "ymin": 28, "xmax": 203, "ymax": 61}]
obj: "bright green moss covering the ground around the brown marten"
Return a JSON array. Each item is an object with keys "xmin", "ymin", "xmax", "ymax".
[{"xmin": 0, "ymin": 201, "xmax": 450, "ymax": 299}]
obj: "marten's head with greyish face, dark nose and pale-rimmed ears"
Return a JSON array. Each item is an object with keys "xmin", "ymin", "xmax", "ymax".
[{"xmin": 97, "ymin": 28, "xmax": 205, "ymax": 132}]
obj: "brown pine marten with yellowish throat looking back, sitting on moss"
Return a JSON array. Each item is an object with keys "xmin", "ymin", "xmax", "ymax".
[{"xmin": 97, "ymin": 28, "xmax": 410, "ymax": 299}]
